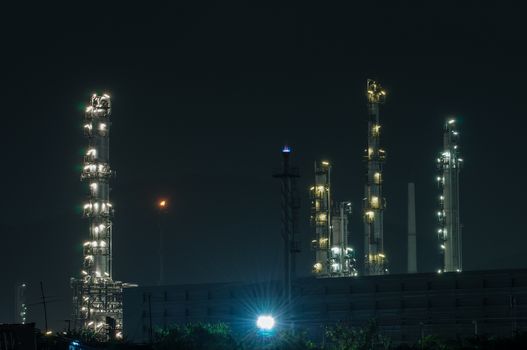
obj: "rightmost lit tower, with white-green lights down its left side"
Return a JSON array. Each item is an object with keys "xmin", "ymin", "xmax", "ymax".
[{"xmin": 437, "ymin": 119, "xmax": 463, "ymax": 273}]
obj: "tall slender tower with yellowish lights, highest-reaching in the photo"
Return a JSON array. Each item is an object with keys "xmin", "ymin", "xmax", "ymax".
[{"xmin": 363, "ymin": 79, "xmax": 388, "ymax": 275}]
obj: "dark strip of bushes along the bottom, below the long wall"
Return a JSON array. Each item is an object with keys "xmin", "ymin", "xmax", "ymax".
[{"xmin": 38, "ymin": 321, "xmax": 527, "ymax": 350}]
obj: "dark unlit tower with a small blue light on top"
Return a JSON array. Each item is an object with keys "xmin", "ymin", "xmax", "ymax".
[{"xmin": 273, "ymin": 146, "xmax": 300, "ymax": 303}]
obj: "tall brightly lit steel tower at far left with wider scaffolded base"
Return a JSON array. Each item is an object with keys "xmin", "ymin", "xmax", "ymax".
[{"xmin": 72, "ymin": 94, "xmax": 123, "ymax": 339}]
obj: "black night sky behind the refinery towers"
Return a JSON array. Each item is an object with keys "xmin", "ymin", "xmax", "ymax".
[{"xmin": 0, "ymin": 1, "xmax": 527, "ymax": 329}]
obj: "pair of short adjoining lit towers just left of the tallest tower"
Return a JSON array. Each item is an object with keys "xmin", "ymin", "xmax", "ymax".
[{"xmin": 311, "ymin": 161, "xmax": 357, "ymax": 277}]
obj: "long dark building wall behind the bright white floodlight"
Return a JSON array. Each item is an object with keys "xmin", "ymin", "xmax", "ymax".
[{"xmin": 124, "ymin": 270, "xmax": 527, "ymax": 342}]
